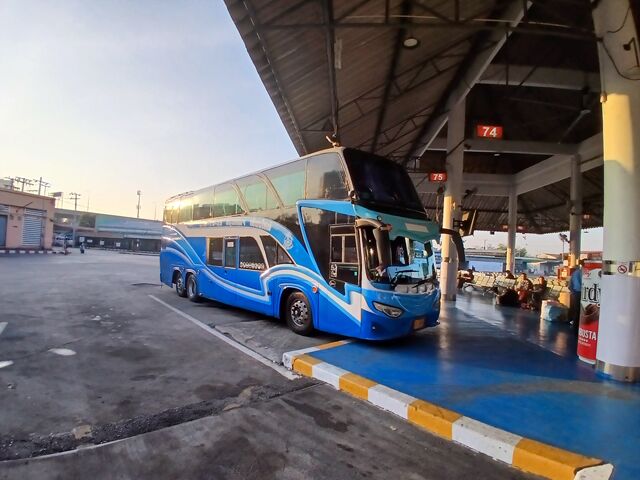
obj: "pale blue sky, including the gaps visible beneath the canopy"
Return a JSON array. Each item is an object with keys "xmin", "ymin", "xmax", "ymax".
[{"xmin": 0, "ymin": 0, "xmax": 602, "ymax": 253}]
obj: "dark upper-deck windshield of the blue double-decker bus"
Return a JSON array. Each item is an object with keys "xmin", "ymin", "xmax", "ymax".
[{"xmin": 344, "ymin": 148, "xmax": 424, "ymax": 214}]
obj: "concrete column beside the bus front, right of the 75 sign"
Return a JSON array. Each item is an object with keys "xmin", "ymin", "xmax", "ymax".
[{"xmin": 440, "ymin": 101, "xmax": 465, "ymax": 301}]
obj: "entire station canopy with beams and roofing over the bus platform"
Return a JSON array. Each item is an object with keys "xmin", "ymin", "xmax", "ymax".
[{"xmin": 225, "ymin": 0, "xmax": 604, "ymax": 233}]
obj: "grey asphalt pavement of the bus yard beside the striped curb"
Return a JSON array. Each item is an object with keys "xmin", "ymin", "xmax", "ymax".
[{"xmin": 0, "ymin": 250, "xmax": 532, "ymax": 479}]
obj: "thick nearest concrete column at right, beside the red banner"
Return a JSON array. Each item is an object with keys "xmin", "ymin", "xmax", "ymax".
[{"xmin": 593, "ymin": 0, "xmax": 640, "ymax": 381}]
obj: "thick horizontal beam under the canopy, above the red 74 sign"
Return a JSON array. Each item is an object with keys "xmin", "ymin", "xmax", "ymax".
[{"xmin": 478, "ymin": 65, "xmax": 600, "ymax": 92}]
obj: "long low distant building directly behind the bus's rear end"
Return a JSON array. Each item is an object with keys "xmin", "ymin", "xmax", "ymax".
[{"xmin": 54, "ymin": 208, "xmax": 162, "ymax": 252}]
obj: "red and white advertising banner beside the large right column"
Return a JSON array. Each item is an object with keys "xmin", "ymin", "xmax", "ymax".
[{"xmin": 578, "ymin": 261, "xmax": 602, "ymax": 363}]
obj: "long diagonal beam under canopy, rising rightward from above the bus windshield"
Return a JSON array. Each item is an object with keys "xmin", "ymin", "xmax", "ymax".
[{"xmin": 405, "ymin": 0, "xmax": 531, "ymax": 163}]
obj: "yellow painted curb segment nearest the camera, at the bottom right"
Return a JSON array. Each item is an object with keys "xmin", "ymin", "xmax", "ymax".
[{"xmin": 513, "ymin": 438, "xmax": 602, "ymax": 480}]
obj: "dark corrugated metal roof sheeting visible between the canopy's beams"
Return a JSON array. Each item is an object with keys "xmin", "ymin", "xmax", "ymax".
[{"xmin": 225, "ymin": 0, "xmax": 603, "ymax": 232}]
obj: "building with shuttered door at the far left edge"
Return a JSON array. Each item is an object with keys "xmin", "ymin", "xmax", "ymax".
[{"xmin": 0, "ymin": 188, "xmax": 55, "ymax": 250}]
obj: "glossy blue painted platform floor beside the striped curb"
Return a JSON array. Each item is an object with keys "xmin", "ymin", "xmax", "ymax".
[{"xmin": 312, "ymin": 293, "xmax": 640, "ymax": 480}]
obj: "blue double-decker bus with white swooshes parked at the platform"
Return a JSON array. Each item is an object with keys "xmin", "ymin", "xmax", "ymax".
[{"xmin": 160, "ymin": 147, "xmax": 440, "ymax": 340}]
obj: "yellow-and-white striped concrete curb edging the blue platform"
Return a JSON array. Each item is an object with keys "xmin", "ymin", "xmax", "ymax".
[{"xmin": 283, "ymin": 348, "xmax": 613, "ymax": 480}]
